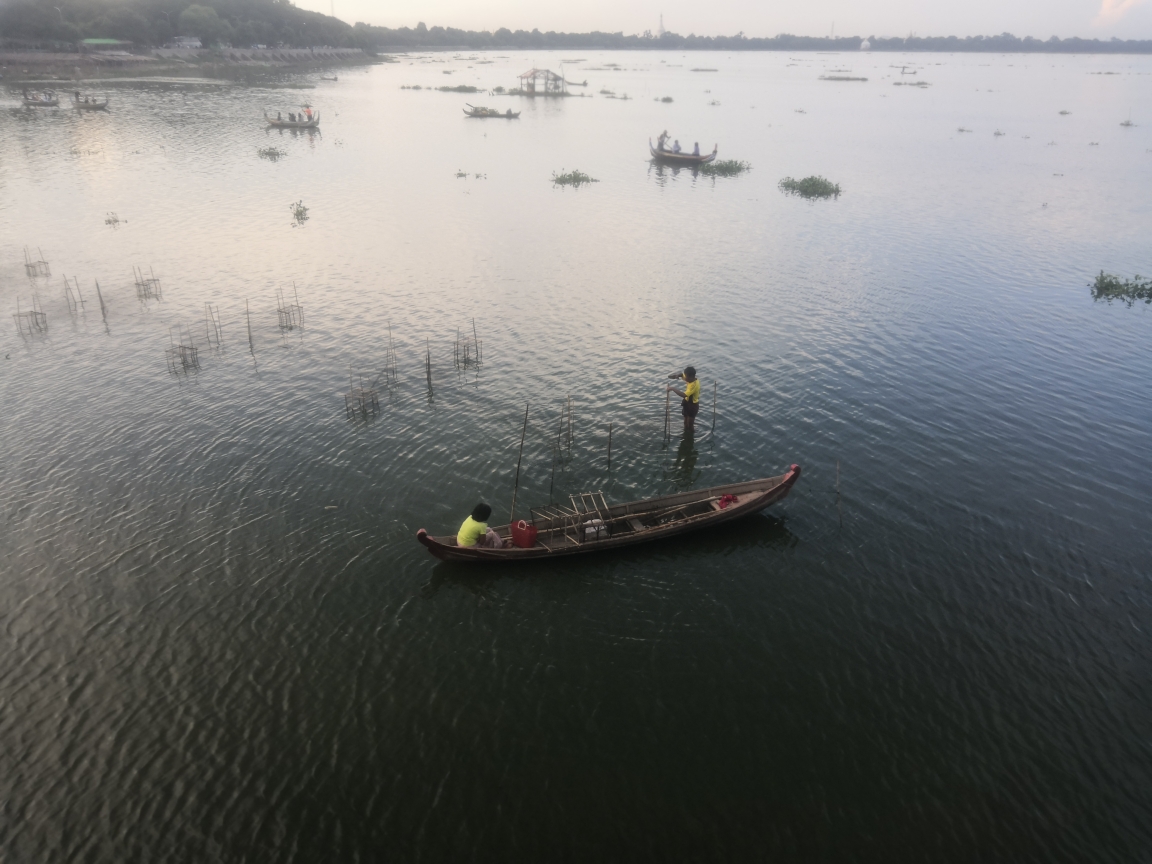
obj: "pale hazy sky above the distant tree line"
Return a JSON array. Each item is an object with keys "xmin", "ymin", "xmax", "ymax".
[{"xmin": 296, "ymin": 0, "xmax": 1152, "ymax": 39}]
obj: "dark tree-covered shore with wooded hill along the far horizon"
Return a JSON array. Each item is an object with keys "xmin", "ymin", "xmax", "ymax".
[{"xmin": 0, "ymin": 0, "xmax": 1152, "ymax": 54}]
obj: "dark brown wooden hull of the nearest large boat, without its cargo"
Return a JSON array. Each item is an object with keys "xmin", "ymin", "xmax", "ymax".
[{"xmin": 416, "ymin": 465, "xmax": 801, "ymax": 563}]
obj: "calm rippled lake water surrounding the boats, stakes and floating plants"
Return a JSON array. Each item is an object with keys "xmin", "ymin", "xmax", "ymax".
[{"xmin": 0, "ymin": 52, "xmax": 1152, "ymax": 862}]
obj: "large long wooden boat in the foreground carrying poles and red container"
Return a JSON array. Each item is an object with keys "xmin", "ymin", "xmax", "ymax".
[{"xmin": 416, "ymin": 465, "xmax": 799, "ymax": 563}]
